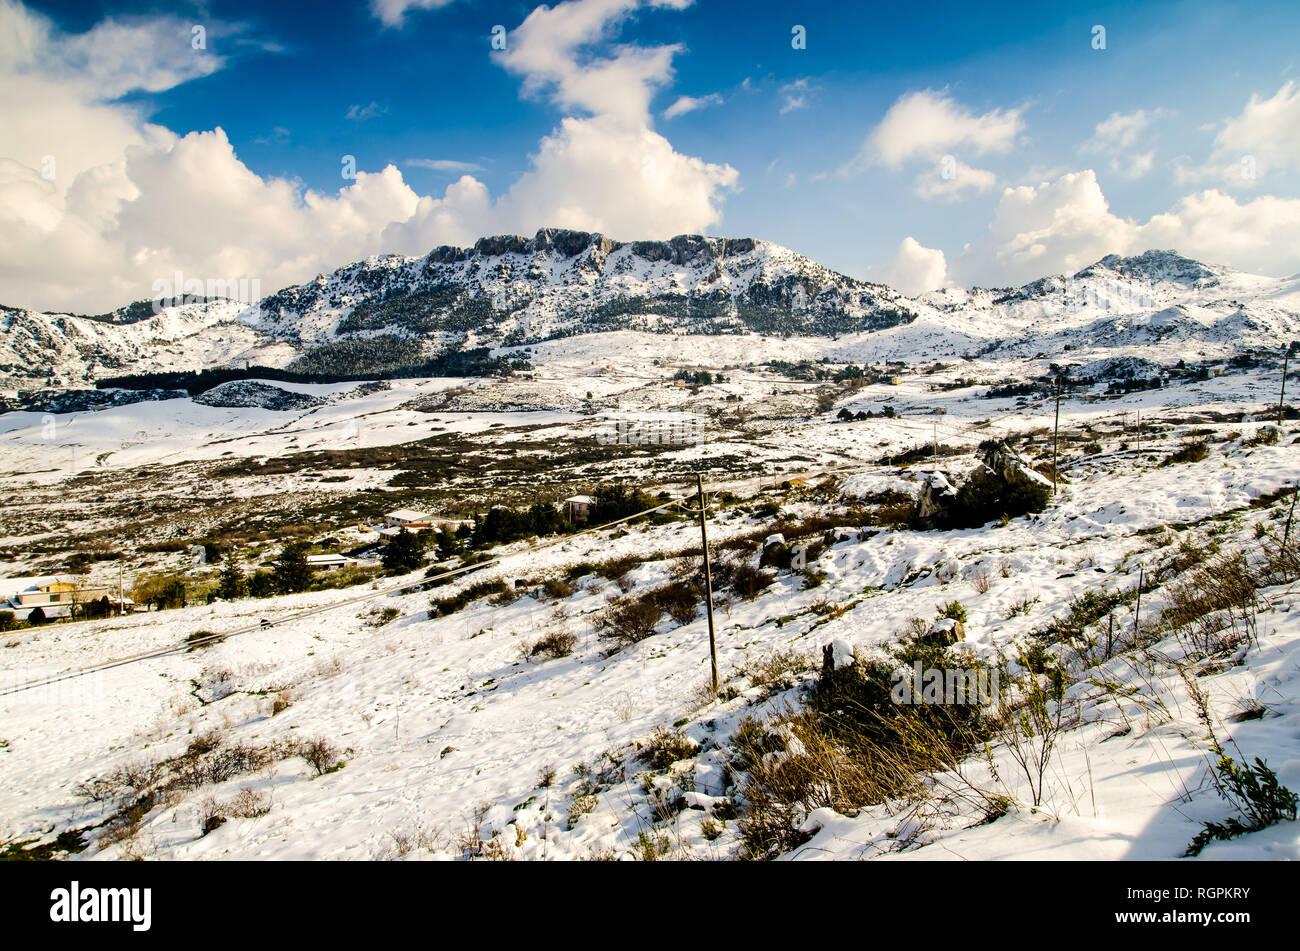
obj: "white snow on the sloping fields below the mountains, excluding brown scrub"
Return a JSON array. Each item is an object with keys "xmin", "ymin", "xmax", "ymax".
[{"xmin": 0, "ymin": 350, "xmax": 1300, "ymax": 860}]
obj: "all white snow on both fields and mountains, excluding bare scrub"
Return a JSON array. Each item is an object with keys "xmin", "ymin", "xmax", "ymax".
[{"xmin": 0, "ymin": 246, "xmax": 1300, "ymax": 861}]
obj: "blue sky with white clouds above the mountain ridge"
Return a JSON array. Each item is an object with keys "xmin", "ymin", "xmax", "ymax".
[{"xmin": 0, "ymin": 0, "xmax": 1300, "ymax": 307}]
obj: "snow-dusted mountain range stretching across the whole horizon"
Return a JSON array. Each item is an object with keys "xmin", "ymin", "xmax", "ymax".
[{"xmin": 0, "ymin": 242, "xmax": 1300, "ymax": 390}]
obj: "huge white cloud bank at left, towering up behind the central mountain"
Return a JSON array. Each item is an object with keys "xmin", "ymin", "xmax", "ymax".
[{"xmin": 0, "ymin": 0, "xmax": 737, "ymax": 313}]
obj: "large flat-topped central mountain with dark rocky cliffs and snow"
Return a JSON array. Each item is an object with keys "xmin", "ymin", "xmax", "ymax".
[{"xmin": 260, "ymin": 229, "xmax": 915, "ymax": 346}]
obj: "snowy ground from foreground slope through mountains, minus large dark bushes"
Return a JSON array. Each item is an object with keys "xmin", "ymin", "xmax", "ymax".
[{"xmin": 0, "ymin": 246, "xmax": 1300, "ymax": 860}]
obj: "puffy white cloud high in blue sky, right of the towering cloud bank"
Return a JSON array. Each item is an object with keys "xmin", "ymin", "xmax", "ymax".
[{"xmin": 854, "ymin": 90, "xmax": 1024, "ymax": 168}]
